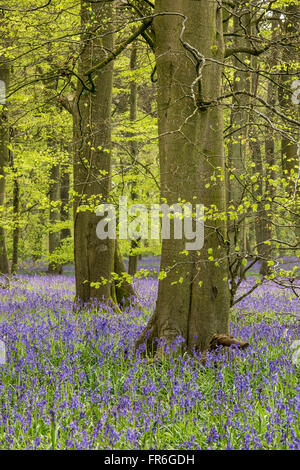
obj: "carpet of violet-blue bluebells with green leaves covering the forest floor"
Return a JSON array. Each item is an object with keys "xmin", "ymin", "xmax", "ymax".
[{"xmin": 0, "ymin": 268, "xmax": 300, "ymax": 450}]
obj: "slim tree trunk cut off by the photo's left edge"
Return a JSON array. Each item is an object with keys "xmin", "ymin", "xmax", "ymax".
[{"xmin": 0, "ymin": 51, "xmax": 10, "ymax": 274}]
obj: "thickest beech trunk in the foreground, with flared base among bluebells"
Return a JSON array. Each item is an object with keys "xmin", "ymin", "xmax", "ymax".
[{"xmin": 136, "ymin": 0, "xmax": 229, "ymax": 353}]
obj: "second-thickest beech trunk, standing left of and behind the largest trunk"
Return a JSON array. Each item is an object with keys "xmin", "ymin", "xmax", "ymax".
[{"xmin": 73, "ymin": 1, "xmax": 115, "ymax": 302}]
